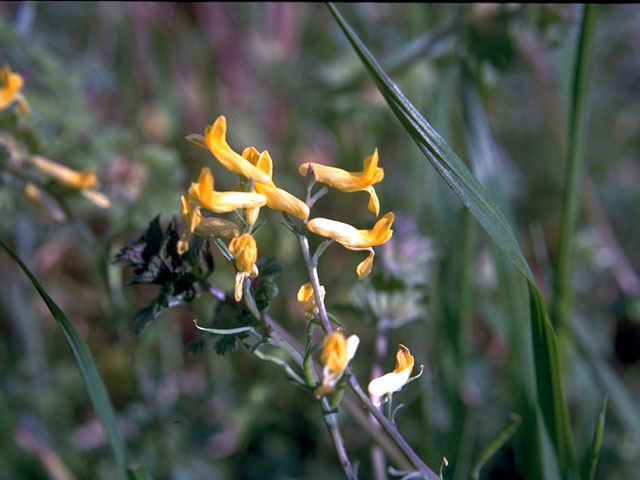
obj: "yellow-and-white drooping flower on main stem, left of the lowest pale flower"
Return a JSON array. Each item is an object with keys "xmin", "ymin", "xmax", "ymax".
[{"xmin": 314, "ymin": 332, "xmax": 360, "ymax": 398}]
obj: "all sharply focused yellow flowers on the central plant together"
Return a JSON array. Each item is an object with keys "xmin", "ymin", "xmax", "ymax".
[{"xmin": 177, "ymin": 116, "xmax": 413, "ymax": 404}]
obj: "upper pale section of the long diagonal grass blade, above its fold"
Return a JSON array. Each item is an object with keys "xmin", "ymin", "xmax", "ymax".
[{"xmin": 328, "ymin": 3, "xmax": 534, "ymax": 282}]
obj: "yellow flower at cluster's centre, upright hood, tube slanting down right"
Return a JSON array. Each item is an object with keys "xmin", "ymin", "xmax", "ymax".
[{"xmin": 242, "ymin": 147, "xmax": 309, "ymax": 220}]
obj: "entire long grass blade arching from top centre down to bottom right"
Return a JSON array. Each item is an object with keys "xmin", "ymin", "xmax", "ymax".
[{"xmin": 328, "ymin": 3, "xmax": 578, "ymax": 478}]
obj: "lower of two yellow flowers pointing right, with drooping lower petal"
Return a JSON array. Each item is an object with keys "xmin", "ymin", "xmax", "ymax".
[{"xmin": 307, "ymin": 212, "xmax": 394, "ymax": 280}]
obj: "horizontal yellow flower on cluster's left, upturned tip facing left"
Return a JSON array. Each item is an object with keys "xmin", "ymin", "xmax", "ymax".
[{"xmin": 189, "ymin": 167, "xmax": 267, "ymax": 213}]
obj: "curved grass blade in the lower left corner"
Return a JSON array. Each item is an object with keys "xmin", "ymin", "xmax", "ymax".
[{"xmin": 0, "ymin": 240, "xmax": 127, "ymax": 480}]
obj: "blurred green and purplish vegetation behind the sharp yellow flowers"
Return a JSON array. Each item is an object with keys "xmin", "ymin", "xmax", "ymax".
[{"xmin": 0, "ymin": 2, "xmax": 640, "ymax": 479}]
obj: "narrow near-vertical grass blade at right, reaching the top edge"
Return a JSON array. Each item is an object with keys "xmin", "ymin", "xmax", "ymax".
[{"xmin": 551, "ymin": 4, "xmax": 596, "ymax": 340}]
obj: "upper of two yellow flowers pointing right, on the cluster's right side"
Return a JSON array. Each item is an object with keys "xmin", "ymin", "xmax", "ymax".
[{"xmin": 299, "ymin": 148, "xmax": 384, "ymax": 216}]
